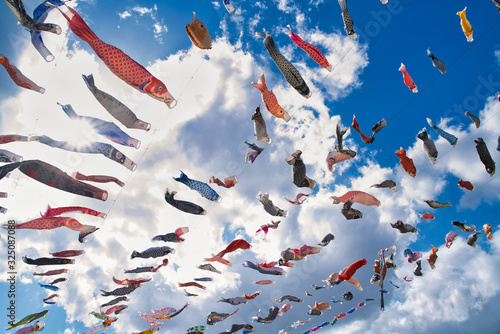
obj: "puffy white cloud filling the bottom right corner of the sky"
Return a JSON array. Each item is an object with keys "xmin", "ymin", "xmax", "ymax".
[{"xmin": 337, "ymin": 238, "xmax": 500, "ymax": 333}]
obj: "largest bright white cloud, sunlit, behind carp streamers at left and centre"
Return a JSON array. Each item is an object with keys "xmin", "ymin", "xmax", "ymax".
[{"xmin": 2, "ymin": 18, "xmax": 372, "ymax": 331}]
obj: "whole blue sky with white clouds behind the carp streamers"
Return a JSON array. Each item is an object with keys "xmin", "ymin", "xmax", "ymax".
[{"xmin": 0, "ymin": 0, "xmax": 500, "ymax": 334}]
